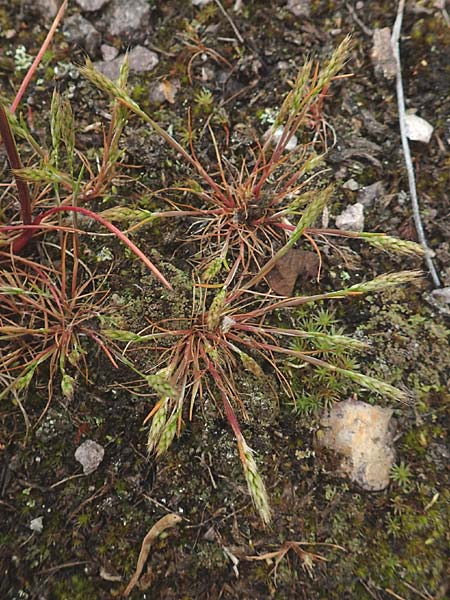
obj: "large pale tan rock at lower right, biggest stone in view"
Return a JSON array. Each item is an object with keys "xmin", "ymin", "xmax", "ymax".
[{"xmin": 320, "ymin": 399, "xmax": 395, "ymax": 492}]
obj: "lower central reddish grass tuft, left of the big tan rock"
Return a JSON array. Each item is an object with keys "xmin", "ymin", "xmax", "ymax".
[{"xmin": 105, "ymin": 271, "xmax": 420, "ymax": 524}]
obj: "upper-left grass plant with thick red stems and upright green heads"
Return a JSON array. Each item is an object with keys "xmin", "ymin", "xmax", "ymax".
[{"xmin": 0, "ymin": 63, "xmax": 171, "ymax": 289}]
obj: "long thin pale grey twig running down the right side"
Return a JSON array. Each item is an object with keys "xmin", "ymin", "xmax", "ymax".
[{"xmin": 391, "ymin": 0, "xmax": 441, "ymax": 288}]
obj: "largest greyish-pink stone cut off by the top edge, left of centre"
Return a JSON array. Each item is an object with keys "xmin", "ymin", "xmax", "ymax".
[{"xmin": 105, "ymin": 0, "xmax": 150, "ymax": 38}]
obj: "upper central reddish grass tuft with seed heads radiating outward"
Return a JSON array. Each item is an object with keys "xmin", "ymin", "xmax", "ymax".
[{"xmin": 81, "ymin": 38, "xmax": 421, "ymax": 288}]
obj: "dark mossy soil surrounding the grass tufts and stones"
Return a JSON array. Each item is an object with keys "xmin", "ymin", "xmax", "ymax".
[{"xmin": 0, "ymin": 0, "xmax": 450, "ymax": 600}]
